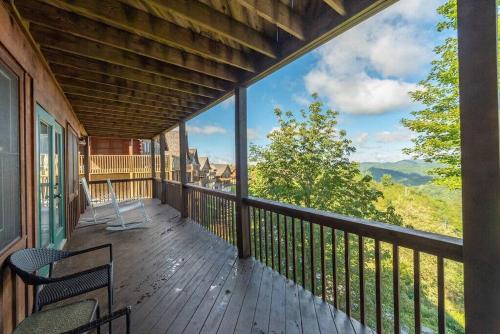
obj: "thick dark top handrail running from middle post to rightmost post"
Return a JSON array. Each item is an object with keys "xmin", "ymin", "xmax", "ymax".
[{"xmin": 244, "ymin": 197, "xmax": 463, "ymax": 262}]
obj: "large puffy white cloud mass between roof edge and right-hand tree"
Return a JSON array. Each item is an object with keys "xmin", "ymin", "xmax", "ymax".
[{"xmin": 304, "ymin": 0, "xmax": 442, "ymax": 114}]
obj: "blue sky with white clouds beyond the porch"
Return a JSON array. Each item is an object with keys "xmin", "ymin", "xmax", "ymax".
[{"xmin": 187, "ymin": 0, "xmax": 452, "ymax": 163}]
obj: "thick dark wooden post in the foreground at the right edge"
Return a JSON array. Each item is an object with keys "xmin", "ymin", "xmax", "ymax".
[{"xmin": 458, "ymin": 0, "xmax": 500, "ymax": 333}]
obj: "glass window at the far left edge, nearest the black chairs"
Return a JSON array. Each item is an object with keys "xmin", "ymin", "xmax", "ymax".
[{"xmin": 0, "ymin": 63, "xmax": 21, "ymax": 249}]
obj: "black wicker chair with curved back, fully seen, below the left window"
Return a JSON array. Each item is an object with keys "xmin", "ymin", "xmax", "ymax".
[{"xmin": 8, "ymin": 244, "xmax": 113, "ymax": 314}]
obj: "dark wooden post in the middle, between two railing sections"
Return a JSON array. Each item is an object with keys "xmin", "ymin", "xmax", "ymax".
[{"xmin": 234, "ymin": 87, "xmax": 251, "ymax": 258}]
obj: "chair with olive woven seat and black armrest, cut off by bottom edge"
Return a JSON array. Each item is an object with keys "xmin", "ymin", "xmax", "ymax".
[{"xmin": 13, "ymin": 299, "xmax": 132, "ymax": 334}]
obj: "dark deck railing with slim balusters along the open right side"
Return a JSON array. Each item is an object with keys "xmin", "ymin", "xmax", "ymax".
[{"xmin": 185, "ymin": 185, "xmax": 463, "ymax": 333}]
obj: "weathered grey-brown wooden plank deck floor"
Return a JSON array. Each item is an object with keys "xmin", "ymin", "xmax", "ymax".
[{"xmin": 56, "ymin": 200, "xmax": 371, "ymax": 334}]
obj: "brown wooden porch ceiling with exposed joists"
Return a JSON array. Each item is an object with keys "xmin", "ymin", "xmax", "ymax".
[{"xmin": 12, "ymin": 0, "xmax": 396, "ymax": 138}]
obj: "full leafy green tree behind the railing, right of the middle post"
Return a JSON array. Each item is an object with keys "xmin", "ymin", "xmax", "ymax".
[{"xmin": 250, "ymin": 95, "xmax": 401, "ymax": 225}]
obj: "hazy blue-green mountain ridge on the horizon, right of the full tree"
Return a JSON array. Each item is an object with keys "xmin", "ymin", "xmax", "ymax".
[{"xmin": 360, "ymin": 160, "xmax": 439, "ymax": 186}]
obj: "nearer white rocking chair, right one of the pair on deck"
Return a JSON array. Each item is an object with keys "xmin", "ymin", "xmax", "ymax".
[{"xmin": 106, "ymin": 179, "xmax": 151, "ymax": 231}]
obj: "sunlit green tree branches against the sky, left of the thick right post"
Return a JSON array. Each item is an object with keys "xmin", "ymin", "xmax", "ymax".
[{"xmin": 402, "ymin": 0, "xmax": 461, "ymax": 189}]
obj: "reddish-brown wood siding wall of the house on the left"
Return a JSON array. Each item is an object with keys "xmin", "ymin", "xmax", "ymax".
[{"xmin": 0, "ymin": 2, "xmax": 84, "ymax": 334}]
